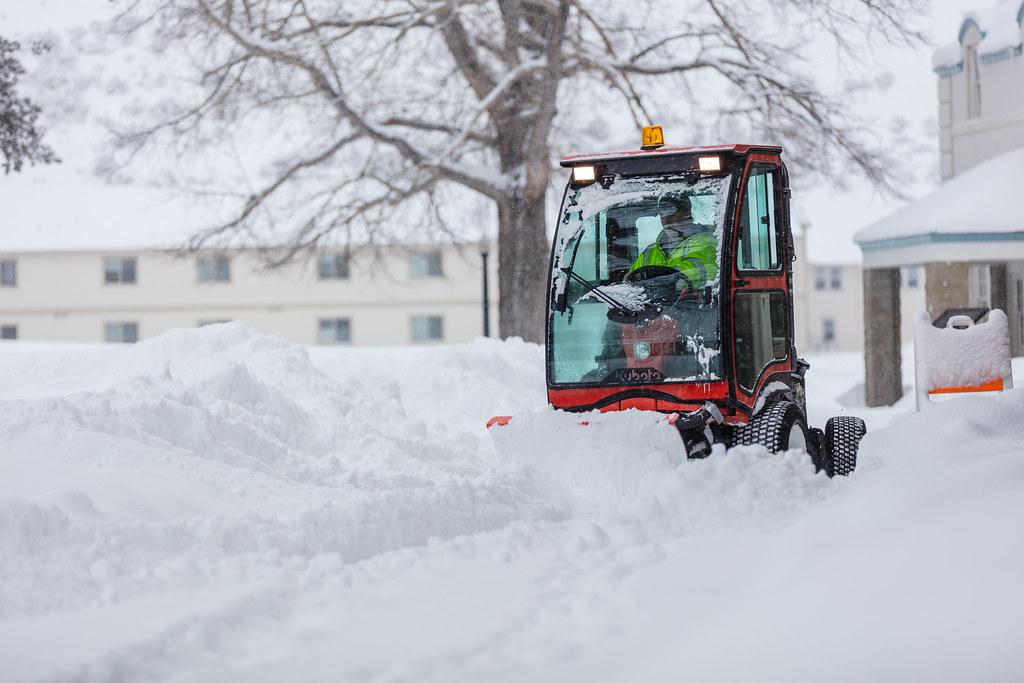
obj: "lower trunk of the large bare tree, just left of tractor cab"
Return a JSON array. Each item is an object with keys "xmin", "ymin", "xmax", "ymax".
[{"xmin": 498, "ymin": 194, "xmax": 549, "ymax": 342}]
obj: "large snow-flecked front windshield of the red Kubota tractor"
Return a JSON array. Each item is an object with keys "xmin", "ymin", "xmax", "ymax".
[{"xmin": 549, "ymin": 176, "xmax": 730, "ymax": 384}]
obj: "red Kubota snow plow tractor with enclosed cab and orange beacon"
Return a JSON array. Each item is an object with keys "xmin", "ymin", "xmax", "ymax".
[{"xmin": 487, "ymin": 127, "xmax": 865, "ymax": 476}]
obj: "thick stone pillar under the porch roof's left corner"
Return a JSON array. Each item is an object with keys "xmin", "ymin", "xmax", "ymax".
[{"xmin": 863, "ymin": 268, "xmax": 903, "ymax": 408}]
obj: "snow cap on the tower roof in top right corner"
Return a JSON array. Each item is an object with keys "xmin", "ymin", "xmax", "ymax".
[{"xmin": 932, "ymin": 0, "xmax": 1024, "ymax": 75}]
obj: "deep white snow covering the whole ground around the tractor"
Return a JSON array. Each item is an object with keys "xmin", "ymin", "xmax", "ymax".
[{"xmin": 0, "ymin": 325, "xmax": 1024, "ymax": 682}]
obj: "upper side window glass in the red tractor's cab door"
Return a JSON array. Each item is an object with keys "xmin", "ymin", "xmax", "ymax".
[{"xmin": 736, "ymin": 168, "xmax": 782, "ymax": 270}]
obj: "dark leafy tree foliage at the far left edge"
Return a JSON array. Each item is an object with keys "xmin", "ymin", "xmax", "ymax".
[{"xmin": 0, "ymin": 37, "xmax": 57, "ymax": 174}]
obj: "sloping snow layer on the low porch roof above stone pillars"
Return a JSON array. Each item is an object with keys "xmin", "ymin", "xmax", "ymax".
[{"xmin": 854, "ymin": 148, "xmax": 1024, "ymax": 249}]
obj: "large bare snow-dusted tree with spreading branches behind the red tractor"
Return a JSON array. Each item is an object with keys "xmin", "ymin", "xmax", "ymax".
[{"xmin": 108, "ymin": 0, "xmax": 922, "ymax": 340}]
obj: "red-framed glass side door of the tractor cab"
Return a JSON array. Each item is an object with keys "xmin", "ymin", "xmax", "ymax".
[{"xmin": 731, "ymin": 154, "xmax": 794, "ymax": 410}]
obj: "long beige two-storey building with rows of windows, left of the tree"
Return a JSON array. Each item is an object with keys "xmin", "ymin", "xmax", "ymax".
[{"xmin": 0, "ymin": 244, "xmax": 497, "ymax": 345}]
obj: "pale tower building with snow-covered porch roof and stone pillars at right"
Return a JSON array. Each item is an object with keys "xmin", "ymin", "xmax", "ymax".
[{"xmin": 855, "ymin": 0, "xmax": 1024, "ymax": 405}]
